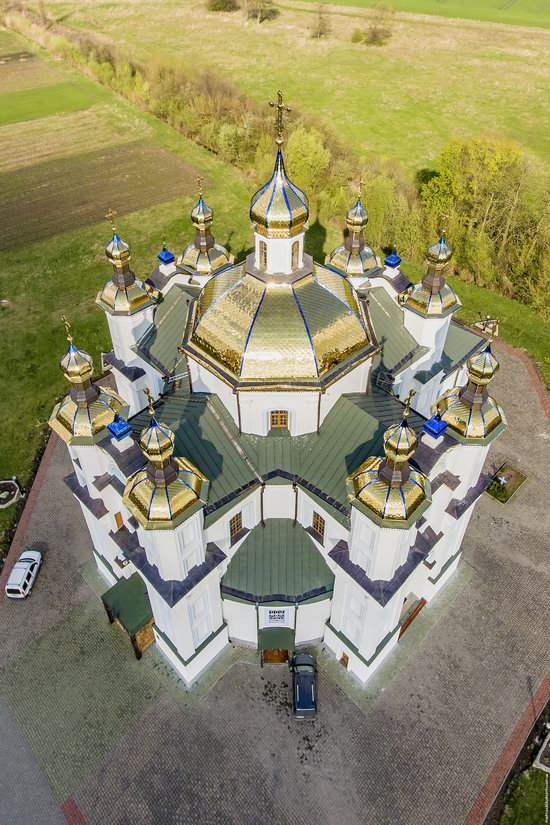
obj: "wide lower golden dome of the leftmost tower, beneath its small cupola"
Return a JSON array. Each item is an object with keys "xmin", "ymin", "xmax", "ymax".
[{"xmin": 49, "ymin": 387, "xmax": 126, "ymax": 444}]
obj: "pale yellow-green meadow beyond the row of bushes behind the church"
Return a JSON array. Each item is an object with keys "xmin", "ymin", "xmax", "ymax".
[{"xmin": 42, "ymin": 0, "xmax": 550, "ymax": 172}]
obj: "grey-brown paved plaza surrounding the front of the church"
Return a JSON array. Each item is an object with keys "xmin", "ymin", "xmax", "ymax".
[{"xmin": 0, "ymin": 345, "xmax": 550, "ymax": 825}]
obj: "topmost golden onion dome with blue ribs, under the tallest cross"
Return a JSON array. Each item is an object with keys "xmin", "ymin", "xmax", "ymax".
[{"xmin": 250, "ymin": 148, "xmax": 309, "ymax": 238}]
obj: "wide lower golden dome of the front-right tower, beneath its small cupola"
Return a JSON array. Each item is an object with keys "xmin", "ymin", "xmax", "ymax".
[{"xmin": 349, "ymin": 454, "xmax": 430, "ymax": 527}]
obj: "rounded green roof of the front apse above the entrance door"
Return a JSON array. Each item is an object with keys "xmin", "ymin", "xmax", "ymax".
[{"xmin": 222, "ymin": 519, "xmax": 334, "ymax": 601}]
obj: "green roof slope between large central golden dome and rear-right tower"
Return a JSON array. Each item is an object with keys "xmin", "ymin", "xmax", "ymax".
[{"xmin": 369, "ymin": 287, "xmax": 427, "ymax": 372}]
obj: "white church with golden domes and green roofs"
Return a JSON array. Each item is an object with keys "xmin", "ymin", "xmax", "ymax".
[{"xmin": 49, "ymin": 93, "xmax": 505, "ymax": 684}]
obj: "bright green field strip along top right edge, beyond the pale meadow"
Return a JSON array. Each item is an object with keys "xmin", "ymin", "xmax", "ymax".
[{"xmin": 308, "ymin": 0, "xmax": 550, "ymax": 27}]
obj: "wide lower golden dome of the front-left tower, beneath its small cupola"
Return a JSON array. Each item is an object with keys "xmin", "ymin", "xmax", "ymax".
[{"xmin": 123, "ymin": 454, "xmax": 208, "ymax": 530}]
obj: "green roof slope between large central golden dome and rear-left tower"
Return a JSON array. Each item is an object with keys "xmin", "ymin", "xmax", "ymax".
[{"xmin": 136, "ymin": 284, "xmax": 200, "ymax": 375}]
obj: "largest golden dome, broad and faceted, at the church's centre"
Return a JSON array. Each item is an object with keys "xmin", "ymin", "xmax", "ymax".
[{"xmin": 184, "ymin": 265, "xmax": 373, "ymax": 389}]
